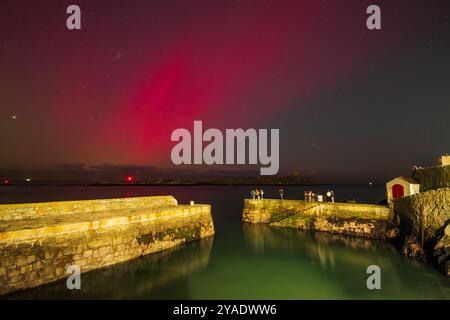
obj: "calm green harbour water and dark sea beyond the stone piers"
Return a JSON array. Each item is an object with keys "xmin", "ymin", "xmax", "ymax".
[{"xmin": 0, "ymin": 186, "xmax": 450, "ymax": 299}]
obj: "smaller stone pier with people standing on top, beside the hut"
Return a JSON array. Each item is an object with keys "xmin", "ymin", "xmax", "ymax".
[{"xmin": 242, "ymin": 199, "xmax": 391, "ymax": 238}]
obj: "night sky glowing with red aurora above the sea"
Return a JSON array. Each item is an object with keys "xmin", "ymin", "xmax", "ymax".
[{"xmin": 0, "ymin": 0, "xmax": 450, "ymax": 183}]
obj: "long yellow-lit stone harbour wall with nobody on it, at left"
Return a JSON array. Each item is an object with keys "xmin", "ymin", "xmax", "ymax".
[{"xmin": 0, "ymin": 197, "xmax": 214, "ymax": 294}]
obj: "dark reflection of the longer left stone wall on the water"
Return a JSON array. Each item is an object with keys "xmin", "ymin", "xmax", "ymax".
[{"xmin": 6, "ymin": 237, "xmax": 213, "ymax": 299}]
